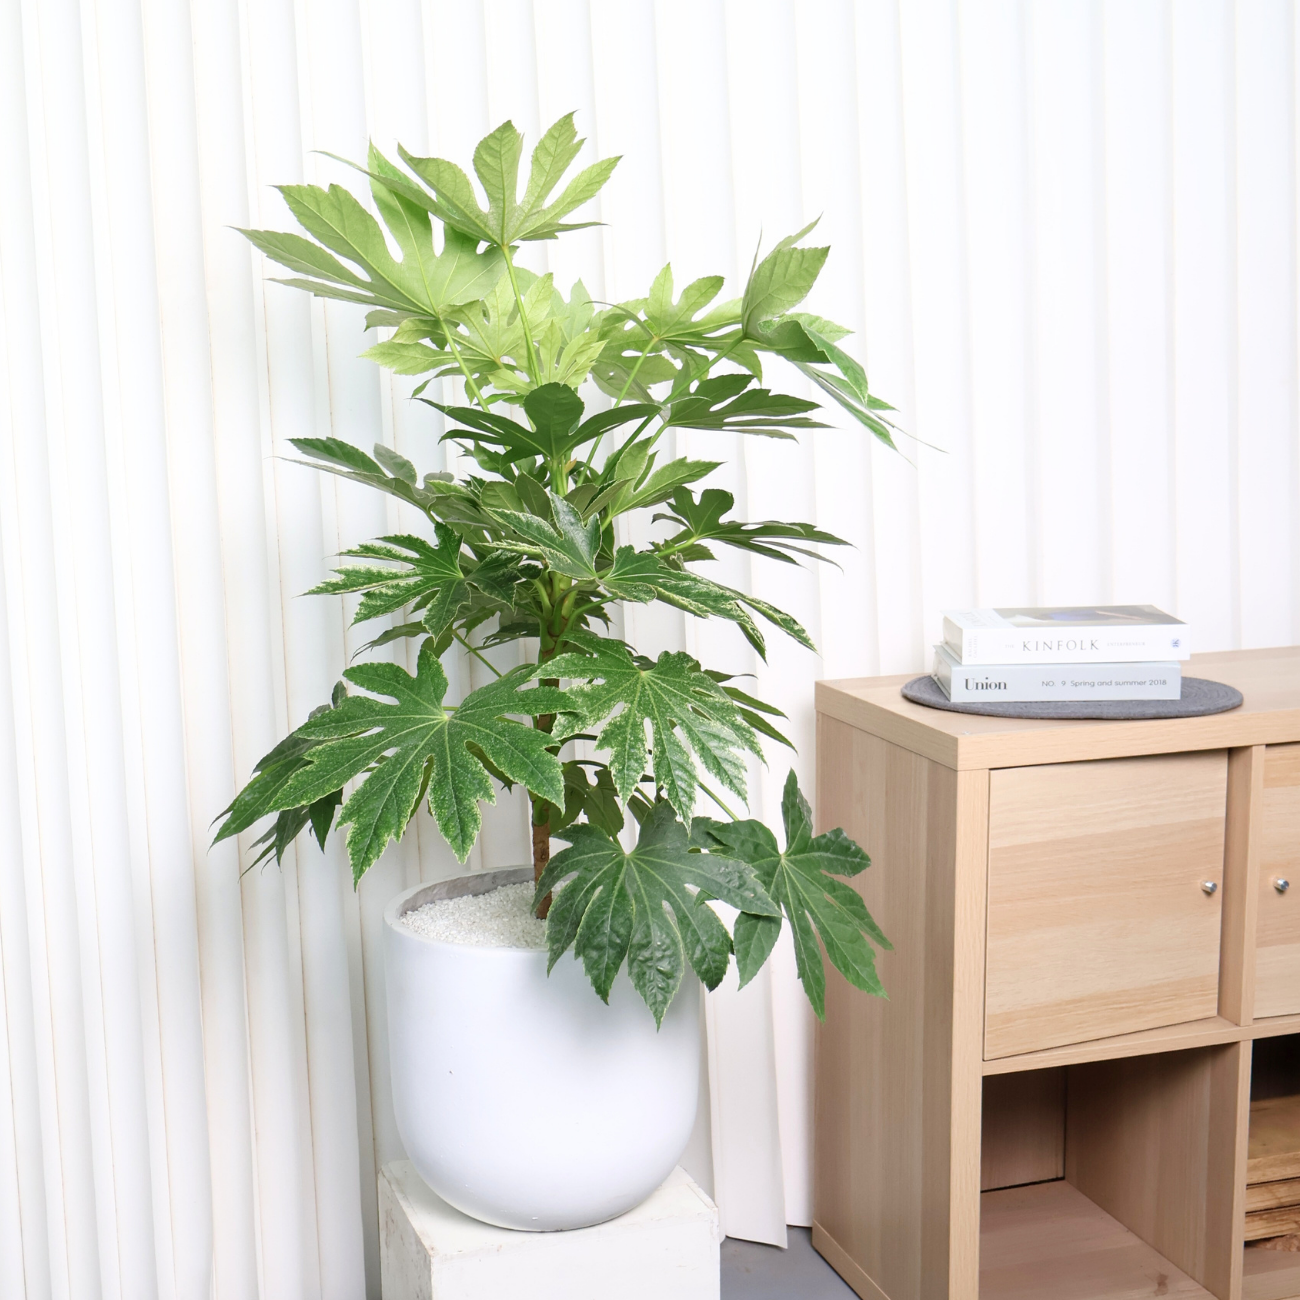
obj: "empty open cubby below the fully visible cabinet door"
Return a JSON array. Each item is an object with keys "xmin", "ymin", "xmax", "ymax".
[{"xmin": 979, "ymin": 1044, "xmax": 1244, "ymax": 1300}]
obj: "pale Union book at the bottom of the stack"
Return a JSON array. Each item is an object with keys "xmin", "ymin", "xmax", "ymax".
[{"xmin": 933, "ymin": 646, "xmax": 1183, "ymax": 705}]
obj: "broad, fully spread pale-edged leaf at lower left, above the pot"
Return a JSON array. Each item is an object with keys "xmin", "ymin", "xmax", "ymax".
[{"xmin": 265, "ymin": 640, "xmax": 572, "ymax": 879}]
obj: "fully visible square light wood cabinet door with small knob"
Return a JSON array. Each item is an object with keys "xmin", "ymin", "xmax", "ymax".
[{"xmin": 984, "ymin": 750, "xmax": 1227, "ymax": 1058}]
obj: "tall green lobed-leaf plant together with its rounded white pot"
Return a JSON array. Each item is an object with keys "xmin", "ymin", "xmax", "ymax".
[{"xmin": 217, "ymin": 114, "xmax": 893, "ymax": 1229}]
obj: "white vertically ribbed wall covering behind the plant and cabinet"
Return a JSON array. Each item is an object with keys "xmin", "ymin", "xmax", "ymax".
[{"xmin": 0, "ymin": 0, "xmax": 1300, "ymax": 1300}]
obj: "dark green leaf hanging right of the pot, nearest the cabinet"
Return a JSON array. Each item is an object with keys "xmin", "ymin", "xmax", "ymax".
[{"xmin": 692, "ymin": 771, "xmax": 893, "ymax": 1019}]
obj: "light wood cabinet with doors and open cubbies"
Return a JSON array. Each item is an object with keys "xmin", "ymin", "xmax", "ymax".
[{"xmin": 813, "ymin": 647, "xmax": 1300, "ymax": 1300}]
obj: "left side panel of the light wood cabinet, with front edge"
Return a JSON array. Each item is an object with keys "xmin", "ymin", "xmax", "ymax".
[{"xmin": 814, "ymin": 718, "xmax": 988, "ymax": 1300}]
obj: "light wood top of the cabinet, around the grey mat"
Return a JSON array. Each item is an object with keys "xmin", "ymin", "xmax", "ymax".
[{"xmin": 816, "ymin": 646, "xmax": 1300, "ymax": 770}]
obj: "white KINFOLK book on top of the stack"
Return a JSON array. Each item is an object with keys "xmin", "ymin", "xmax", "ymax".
[{"xmin": 944, "ymin": 605, "xmax": 1191, "ymax": 664}]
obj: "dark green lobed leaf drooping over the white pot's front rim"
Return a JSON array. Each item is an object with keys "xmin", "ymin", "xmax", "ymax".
[{"xmin": 537, "ymin": 803, "xmax": 780, "ymax": 1024}]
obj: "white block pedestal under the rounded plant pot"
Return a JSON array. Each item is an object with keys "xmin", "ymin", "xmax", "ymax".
[{"xmin": 380, "ymin": 1160, "xmax": 722, "ymax": 1300}]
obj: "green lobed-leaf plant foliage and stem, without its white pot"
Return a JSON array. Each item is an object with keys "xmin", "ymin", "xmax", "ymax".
[{"xmin": 217, "ymin": 114, "xmax": 893, "ymax": 1019}]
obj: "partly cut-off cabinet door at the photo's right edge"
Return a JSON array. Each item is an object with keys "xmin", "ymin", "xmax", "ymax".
[{"xmin": 1255, "ymin": 745, "xmax": 1300, "ymax": 1018}]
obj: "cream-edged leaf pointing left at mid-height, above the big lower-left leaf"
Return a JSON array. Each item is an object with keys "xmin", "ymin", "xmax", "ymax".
[{"xmin": 308, "ymin": 524, "xmax": 471, "ymax": 637}]
